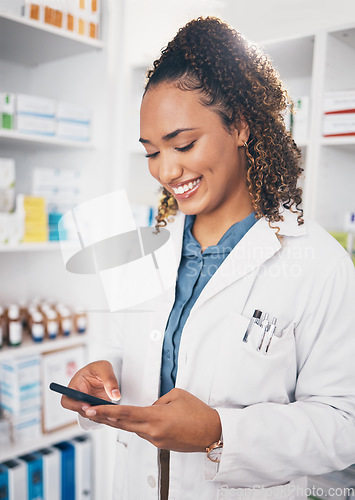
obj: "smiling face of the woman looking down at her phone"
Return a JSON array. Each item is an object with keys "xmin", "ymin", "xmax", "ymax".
[{"xmin": 140, "ymin": 83, "xmax": 252, "ymax": 221}]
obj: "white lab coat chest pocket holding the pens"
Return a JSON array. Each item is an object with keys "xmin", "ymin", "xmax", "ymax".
[{"xmin": 209, "ymin": 312, "xmax": 296, "ymax": 407}]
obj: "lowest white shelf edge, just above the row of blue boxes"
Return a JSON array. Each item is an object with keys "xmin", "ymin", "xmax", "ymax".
[{"xmin": 0, "ymin": 423, "xmax": 83, "ymax": 462}]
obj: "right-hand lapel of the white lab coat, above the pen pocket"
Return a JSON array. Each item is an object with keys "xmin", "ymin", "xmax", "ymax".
[{"xmin": 193, "ymin": 219, "xmax": 281, "ymax": 310}]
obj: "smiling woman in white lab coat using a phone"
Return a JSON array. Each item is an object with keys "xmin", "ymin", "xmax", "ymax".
[{"xmin": 62, "ymin": 18, "xmax": 355, "ymax": 500}]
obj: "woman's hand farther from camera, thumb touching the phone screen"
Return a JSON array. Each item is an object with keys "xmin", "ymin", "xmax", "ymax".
[{"xmin": 61, "ymin": 361, "xmax": 121, "ymax": 417}]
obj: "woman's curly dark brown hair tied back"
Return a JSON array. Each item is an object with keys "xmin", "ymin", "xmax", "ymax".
[{"xmin": 145, "ymin": 17, "xmax": 303, "ymax": 229}]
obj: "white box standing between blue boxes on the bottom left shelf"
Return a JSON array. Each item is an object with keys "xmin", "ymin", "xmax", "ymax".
[{"xmin": 38, "ymin": 447, "xmax": 62, "ymax": 500}]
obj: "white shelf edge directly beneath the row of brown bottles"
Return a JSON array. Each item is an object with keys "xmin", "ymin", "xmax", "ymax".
[{"xmin": 0, "ymin": 333, "xmax": 88, "ymax": 361}]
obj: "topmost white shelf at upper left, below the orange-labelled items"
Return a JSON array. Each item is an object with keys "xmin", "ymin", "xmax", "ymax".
[{"xmin": 0, "ymin": 13, "xmax": 104, "ymax": 66}]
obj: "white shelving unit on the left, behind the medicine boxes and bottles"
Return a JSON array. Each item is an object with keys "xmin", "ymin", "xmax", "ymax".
[{"xmin": 0, "ymin": 4, "xmax": 117, "ymax": 499}]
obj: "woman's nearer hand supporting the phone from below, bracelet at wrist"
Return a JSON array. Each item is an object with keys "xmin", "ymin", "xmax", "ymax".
[{"xmin": 86, "ymin": 389, "xmax": 222, "ymax": 452}]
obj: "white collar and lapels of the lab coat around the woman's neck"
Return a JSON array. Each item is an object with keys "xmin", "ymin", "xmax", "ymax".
[{"xmin": 168, "ymin": 209, "xmax": 307, "ymax": 309}]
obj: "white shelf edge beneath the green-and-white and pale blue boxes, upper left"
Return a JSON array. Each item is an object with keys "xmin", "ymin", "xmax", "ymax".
[{"xmin": 0, "ymin": 129, "xmax": 94, "ymax": 149}]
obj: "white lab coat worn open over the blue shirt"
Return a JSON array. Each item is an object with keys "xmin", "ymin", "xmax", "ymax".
[{"xmin": 82, "ymin": 210, "xmax": 355, "ymax": 500}]
